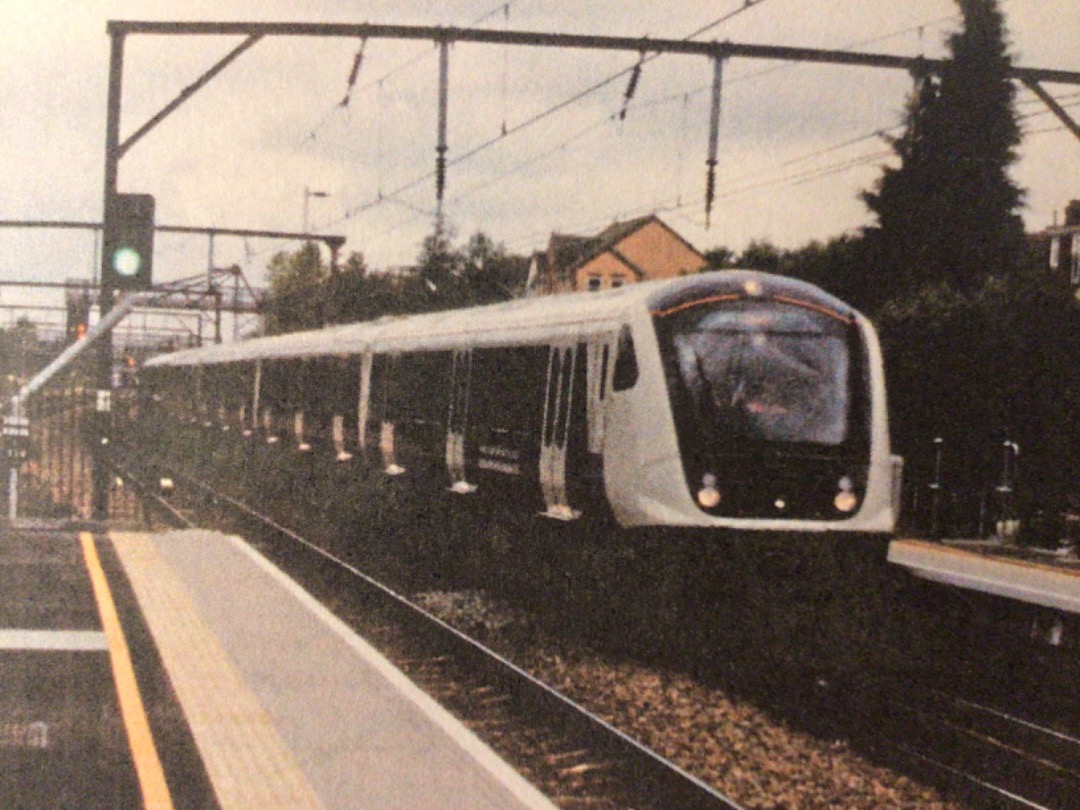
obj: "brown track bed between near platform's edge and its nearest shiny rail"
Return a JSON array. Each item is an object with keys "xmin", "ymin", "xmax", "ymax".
[{"xmin": 117, "ymin": 463, "xmax": 740, "ymax": 810}]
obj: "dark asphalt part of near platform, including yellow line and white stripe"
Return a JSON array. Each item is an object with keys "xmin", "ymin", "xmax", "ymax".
[{"xmin": 0, "ymin": 525, "xmax": 218, "ymax": 810}]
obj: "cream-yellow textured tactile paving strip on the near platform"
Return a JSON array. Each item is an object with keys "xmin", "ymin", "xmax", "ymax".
[{"xmin": 109, "ymin": 532, "xmax": 323, "ymax": 810}]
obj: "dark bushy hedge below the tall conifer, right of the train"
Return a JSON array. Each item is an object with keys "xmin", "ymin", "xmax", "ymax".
[{"xmin": 878, "ymin": 271, "xmax": 1080, "ymax": 535}]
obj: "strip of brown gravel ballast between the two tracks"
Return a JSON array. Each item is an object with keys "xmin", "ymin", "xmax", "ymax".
[{"xmin": 415, "ymin": 591, "xmax": 961, "ymax": 810}]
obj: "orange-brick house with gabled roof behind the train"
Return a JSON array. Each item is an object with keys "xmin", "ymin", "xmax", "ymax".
[{"xmin": 526, "ymin": 215, "xmax": 708, "ymax": 295}]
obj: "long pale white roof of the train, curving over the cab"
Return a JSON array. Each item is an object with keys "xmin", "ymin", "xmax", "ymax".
[{"xmin": 146, "ymin": 270, "xmax": 854, "ymax": 366}]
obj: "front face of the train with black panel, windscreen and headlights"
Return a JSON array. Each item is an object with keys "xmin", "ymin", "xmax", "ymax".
[{"xmin": 626, "ymin": 271, "xmax": 894, "ymax": 531}]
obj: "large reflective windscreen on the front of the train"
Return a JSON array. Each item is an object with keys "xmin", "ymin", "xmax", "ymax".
[{"xmin": 661, "ymin": 300, "xmax": 850, "ymax": 449}]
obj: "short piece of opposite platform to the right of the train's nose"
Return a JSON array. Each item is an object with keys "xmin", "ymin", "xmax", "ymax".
[{"xmin": 888, "ymin": 539, "xmax": 1080, "ymax": 613}]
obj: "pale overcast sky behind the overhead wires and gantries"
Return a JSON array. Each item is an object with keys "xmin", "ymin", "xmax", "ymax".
[{"xmin": 0, "ymin": 0, "xmax": 1080, "ymax": 311}]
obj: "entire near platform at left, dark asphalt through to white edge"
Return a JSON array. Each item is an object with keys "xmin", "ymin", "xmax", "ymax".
[{"xmin": 0, "ymin": 528, "xmax": 553, "ymax": 810}]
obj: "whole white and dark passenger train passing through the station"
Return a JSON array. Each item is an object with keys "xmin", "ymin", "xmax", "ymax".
[{"xmin": 138, "ymin": 270, "xmax": 901, "ymax": 534}]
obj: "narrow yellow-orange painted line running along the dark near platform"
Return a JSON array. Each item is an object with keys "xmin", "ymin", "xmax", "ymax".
[{"xmin": 79, "ymin": 531, "xmax": 173, "ymax": 810}]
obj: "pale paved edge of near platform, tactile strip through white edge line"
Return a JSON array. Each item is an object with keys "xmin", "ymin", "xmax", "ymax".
[{"xmin": 110, "ymin": 531, "xmax": 553, "ymax": 810}]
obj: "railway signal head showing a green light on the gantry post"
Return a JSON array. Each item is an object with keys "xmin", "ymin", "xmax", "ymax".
[{"xmin": 102, "ymin": 194, "xmax": 154, "ymax": 289}]
